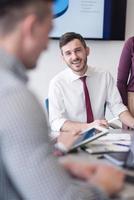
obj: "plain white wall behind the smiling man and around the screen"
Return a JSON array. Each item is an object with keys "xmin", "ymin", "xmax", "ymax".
[{"xmin": 29, "ymin": 0, "xmax": 134, "ymax": 101}]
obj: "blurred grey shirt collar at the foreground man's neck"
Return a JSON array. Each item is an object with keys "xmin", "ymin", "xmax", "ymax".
[{"xmin": 0, "ymin": 49, "xmax": 28, "ymax": 83}]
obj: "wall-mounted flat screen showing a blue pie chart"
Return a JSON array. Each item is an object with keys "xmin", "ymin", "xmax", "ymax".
[{"xmin": 50, "ymin": 0, "xmax": 127, "ymax": 40}]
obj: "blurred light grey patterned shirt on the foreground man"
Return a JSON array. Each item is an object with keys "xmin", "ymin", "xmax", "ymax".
[{"xmin": 0, "ymin": 49, "xmax": 112, "ymax": 200}]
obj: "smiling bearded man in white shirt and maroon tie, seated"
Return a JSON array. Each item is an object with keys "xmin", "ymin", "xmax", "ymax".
[{"xmin": 49, "ymin": 32, "xmax": 134, "ymax": 137}]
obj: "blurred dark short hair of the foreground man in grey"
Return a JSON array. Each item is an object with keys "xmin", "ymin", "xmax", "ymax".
[{"xmin": 0, "ymin": 0, "xmax": 55, "ymax": 34}]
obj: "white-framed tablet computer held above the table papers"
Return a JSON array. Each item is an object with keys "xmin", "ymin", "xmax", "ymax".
[{"xmin": 70, "ymin": 126, "xmax": 108, "ymax": 151}]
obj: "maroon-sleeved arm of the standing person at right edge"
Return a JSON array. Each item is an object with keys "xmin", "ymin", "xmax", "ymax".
[{"xmin": 117, "ymin": 38, "xmax": 132, "ymax": 105}]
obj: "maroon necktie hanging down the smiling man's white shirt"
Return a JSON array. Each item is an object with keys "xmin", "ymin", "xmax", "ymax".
[{"xmin": 80, "ymin": 76, "xmax": 94, "ymax": 123}]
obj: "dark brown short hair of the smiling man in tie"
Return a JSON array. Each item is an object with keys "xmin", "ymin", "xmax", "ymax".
[{"xmin": 59, "ymin": 32, "xmax": 87, "ymax": 49}]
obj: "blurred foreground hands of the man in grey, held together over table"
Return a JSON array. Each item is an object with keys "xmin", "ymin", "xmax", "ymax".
[{"xmin": 61, "ymin": 158, "xmax": 124, "ymax": 196}]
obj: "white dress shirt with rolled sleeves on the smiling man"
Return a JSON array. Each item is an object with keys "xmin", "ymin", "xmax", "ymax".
[{"xmin": 48, "ymin": 67, "xmax": 127, "ymax": 136}]
